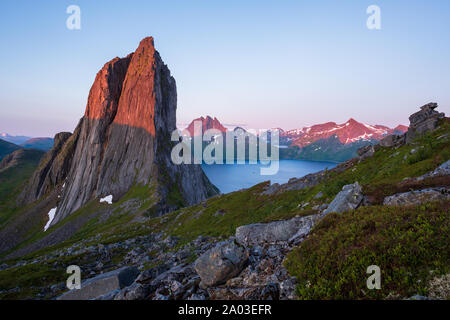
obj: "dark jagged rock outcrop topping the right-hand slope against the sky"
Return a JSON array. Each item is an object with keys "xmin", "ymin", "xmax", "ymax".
[{"xmin": 405, "ymin": 103, "xmax": 445, "ymax": 143}]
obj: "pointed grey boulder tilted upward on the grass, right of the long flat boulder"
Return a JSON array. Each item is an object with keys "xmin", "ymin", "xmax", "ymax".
[{"xmin": 323, "ymin": 182, "xmax": 364, "ymax": 214}]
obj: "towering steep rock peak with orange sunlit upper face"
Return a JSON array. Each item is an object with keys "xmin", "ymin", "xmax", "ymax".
[{"xmin": 19, "ymin": 37, "xmax": 217, "ymax": 225}]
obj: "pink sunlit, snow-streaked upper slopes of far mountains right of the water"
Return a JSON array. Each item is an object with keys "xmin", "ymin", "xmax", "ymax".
[{"xmin": 281, "ymin": 118, "xmax": 407, "ymax": 148}]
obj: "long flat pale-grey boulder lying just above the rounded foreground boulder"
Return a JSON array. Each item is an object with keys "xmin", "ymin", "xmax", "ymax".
[{"xmin": 236, "ymin": 215, "xmax": 319, "ymax": 247}]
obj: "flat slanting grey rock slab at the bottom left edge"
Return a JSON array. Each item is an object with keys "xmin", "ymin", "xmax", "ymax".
[{"xmin": 56, "ymin": 267, "xmax": 139, "ymax": 300}]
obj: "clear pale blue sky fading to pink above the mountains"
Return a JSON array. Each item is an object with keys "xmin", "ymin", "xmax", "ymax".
[{"xmin": 0, "ymin": 0, "xmax": 450, "ymax": 136}]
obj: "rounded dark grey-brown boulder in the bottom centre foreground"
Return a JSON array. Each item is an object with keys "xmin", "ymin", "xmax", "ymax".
[{"xmin": 194, "ymin": 240, "xmax": 249, "ymax": 287}]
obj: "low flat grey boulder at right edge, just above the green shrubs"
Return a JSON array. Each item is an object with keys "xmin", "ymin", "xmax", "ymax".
[{"xmin": 383, "ymin": 187, "xmax": 450, "ymax": 206}]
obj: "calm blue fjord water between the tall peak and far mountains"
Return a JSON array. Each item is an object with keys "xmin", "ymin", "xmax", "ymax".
[{"xmin": 202, "ymin": 160, "xmax": 336, "ymax": 193}]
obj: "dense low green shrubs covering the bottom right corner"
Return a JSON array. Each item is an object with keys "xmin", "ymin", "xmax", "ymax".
[{"xmin": 285, "ymin": 201, "xmax": 450, "ymax": 299}]
